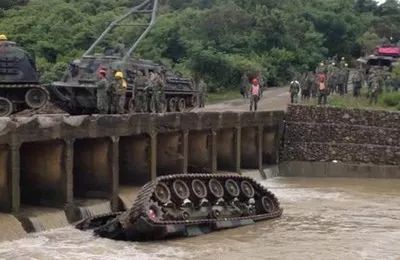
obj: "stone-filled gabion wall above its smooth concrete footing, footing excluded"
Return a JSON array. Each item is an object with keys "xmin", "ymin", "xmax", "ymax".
[{"xmin": 283, "ymin": 105, "xmax": 400, "ymax": 165}]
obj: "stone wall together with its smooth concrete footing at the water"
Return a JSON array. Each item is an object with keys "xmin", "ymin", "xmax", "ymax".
[{"xmin": 280, "ymin": 105, "xmax": 400, "ymax": 178}]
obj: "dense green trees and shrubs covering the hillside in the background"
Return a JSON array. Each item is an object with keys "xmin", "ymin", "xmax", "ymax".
[{"xmin": 0, "ymin": 0, "xmax": 400, "ymax": 89}]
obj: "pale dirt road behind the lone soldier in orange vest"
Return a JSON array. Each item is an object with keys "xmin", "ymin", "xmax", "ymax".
[{"xmin": 195, "ymin": 87, "xmax": 290, "ymax": 112}]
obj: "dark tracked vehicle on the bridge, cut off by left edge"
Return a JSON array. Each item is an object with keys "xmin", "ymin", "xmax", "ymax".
[{"xmin": 0, "ymin": 40, "xmax": 49, "ymax": 116}]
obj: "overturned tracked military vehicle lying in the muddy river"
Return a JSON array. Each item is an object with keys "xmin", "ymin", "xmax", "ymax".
[{"xmin": 76, "ymin": 174, "xmax": 283, "ymax": 241}]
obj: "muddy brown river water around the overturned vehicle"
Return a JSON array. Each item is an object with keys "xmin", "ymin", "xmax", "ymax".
[{"xmin": 0, "ymin": 178, "xmax": 400, "ymax": 260}]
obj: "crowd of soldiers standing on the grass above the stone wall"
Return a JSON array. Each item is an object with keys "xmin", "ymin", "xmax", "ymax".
[{"xmin": 290, "ymin": 58, "xmax": 397, "ymax": 105}]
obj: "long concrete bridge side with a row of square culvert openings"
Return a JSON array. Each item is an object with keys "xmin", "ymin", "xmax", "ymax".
[{"xmin": 0, "ymin": 112, "xmax": 284, "ymax": 213}]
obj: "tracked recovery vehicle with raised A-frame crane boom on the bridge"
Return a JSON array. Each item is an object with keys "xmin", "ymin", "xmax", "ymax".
[{"xmin": 49, "ymin": 0, "xmax": 199, "ymax": 114}]
